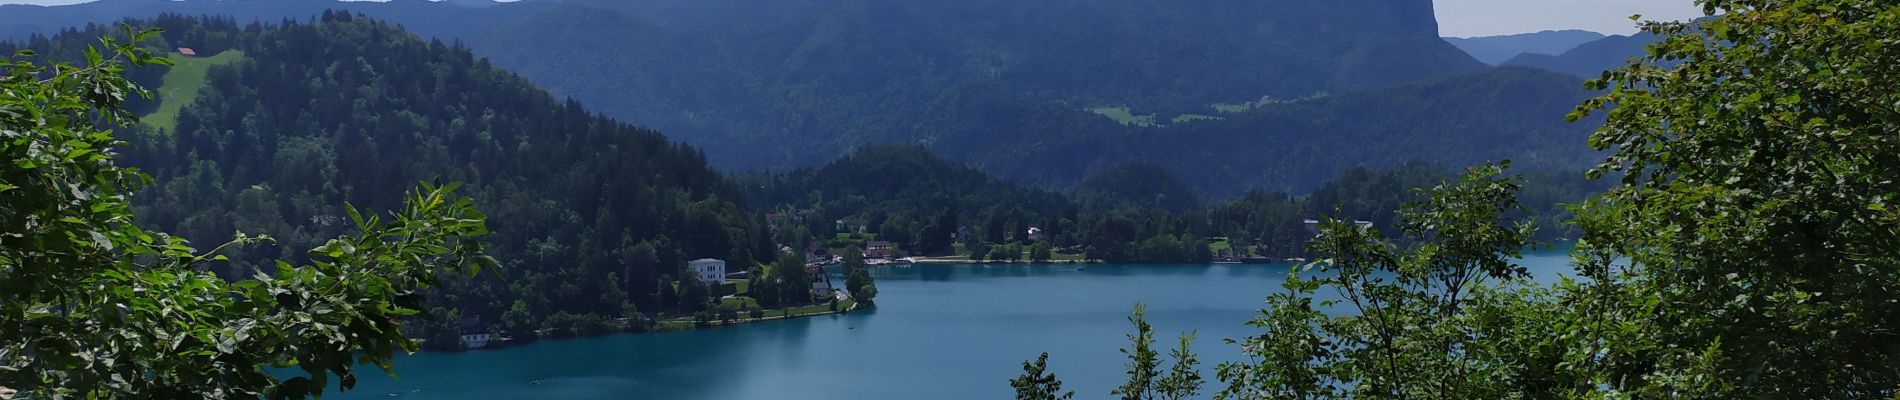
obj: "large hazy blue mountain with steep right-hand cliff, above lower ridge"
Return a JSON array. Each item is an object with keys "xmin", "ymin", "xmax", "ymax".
[{"xmin": 448, "ymin": 0, "xmax": 1480, "ymax": 171}]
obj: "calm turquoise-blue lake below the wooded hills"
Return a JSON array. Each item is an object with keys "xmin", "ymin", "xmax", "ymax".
[{"xmin": 333, "ymin": 248, "xmax": 1569, "ymax": 400}]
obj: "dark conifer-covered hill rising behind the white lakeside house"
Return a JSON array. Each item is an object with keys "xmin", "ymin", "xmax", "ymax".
[{"xmin": 3, "ymin": 13, "xmax": 775, "ymax": 343}]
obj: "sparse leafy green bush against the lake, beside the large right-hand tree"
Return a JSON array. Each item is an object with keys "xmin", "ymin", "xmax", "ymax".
[{"xmin": 1220, "ymin": 165, "xmax": 1533, "ymax": 398}]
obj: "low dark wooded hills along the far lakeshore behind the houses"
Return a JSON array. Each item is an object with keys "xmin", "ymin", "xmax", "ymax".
[{"xmin": 737, "ymin": 146, "xmax": 1604, "ymax": 262}]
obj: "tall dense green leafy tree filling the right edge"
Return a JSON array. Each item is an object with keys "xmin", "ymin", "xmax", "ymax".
[{"xmin": 1579, "ymin": 0, "xmax": 1900, "ymax": 398}]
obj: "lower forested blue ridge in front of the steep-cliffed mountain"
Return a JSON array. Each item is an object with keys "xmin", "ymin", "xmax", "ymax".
[{"xmin": 950, "ymin": 68, "xmax": 1596, "ymax": 197}]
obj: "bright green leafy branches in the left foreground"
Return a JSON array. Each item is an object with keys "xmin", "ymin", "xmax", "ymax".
[{"xmin": 0, "ymin": 28, "xmax": 492, "ymax": 398}]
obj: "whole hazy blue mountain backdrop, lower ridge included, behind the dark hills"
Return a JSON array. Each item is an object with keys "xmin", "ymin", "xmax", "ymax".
[{"xmin": 0, "ymin": 0, "xmax": 1618, "ymax": 195}]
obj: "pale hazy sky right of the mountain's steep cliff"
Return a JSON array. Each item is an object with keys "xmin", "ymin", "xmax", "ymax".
[{"xmin": 0, "ymin": 0, "xmax": 1702, "ymax": 36}]
